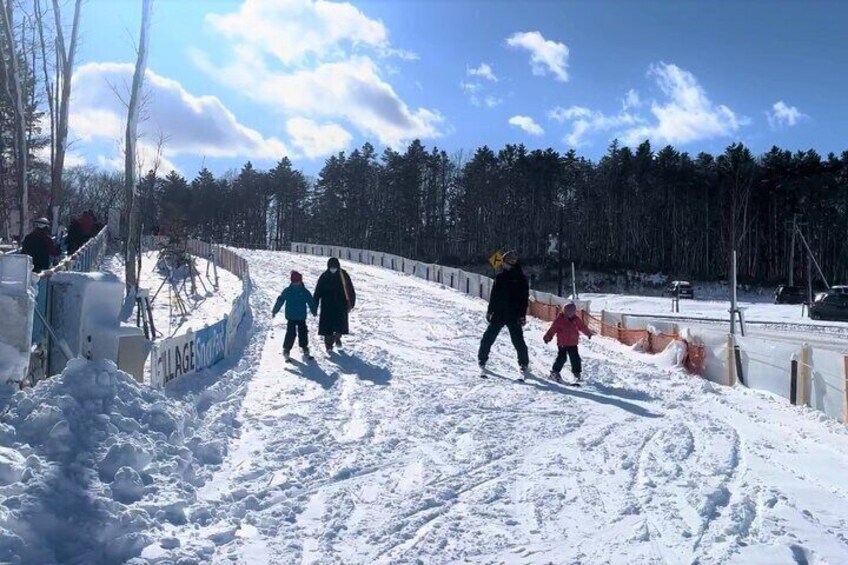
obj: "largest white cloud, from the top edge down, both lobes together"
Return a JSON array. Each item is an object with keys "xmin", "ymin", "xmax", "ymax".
[{"xmin": 198, "ymin": 0, "xmax": 444, "ymax": 146}]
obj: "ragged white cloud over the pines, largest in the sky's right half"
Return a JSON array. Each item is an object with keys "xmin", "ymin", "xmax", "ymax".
[{"xmin": 622, "ymin": 63, "xmax": 750, "ymax": 144}]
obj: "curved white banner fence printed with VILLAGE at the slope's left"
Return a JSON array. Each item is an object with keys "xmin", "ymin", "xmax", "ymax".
[{"xmin": 150, "ymin": 240, "xmax": 248, "ymax": 387}]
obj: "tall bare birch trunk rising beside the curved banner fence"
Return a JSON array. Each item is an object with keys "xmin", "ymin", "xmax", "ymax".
[{"xmin": 124, "ymin": 0, "xmax": 153, "ymax": 296}]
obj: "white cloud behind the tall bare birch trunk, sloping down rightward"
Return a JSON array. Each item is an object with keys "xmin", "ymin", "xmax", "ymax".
[{"xmin": 69, "ymin": 63, "xmax": 290, "ymax": 166}]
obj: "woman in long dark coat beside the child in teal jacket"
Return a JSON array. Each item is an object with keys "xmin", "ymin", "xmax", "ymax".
[{"xmin": 313, "ymin": 257, "xmax": 356, "ymax": 353}]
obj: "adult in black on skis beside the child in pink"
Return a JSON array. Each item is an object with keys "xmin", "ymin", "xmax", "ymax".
[{"xmin": 477, "ymin": 251, "xmax": 530, "ymax": 371}]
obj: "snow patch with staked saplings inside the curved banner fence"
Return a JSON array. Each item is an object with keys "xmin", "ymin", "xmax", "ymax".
[{"xmin": 103, "ymin": 251, "xmax": 241, "ymax": 337}]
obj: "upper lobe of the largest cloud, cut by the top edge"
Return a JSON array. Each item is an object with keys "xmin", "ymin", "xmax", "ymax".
[{"xmin": 206, "ymin": 0, "xmax": 388, "ymax": 64}]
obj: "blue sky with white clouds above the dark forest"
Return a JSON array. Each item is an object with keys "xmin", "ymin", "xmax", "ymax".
[{"xmin": 71, "ymin": 0, "xmax": 848, "ymax": 176}]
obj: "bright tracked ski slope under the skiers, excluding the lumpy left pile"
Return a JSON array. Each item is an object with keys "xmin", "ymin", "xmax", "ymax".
[{"xmin": 153, "ymin": 251, "xmax": 848, "ymax": 563}]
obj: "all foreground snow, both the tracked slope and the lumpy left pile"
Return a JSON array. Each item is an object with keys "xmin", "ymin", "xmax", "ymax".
[{"xmin": 0, "ymin": 252, "xmax": 848, "ymax": 564}]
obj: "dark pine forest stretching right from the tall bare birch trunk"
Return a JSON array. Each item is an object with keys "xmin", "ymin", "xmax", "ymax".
[{"xmin": 70, "ymin": 137, "xmax": 848, "ymax": 284}]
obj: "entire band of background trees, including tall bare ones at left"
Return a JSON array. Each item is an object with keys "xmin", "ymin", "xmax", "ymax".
[{"xmin": 0, "ymin": 0, "xmax": 848, "ymax": 283}]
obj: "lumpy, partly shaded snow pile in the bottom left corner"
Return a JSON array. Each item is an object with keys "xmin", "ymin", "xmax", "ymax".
[{"xmin": 0, "ymin": 359, "xmax": 209, "ymax": 563}]
